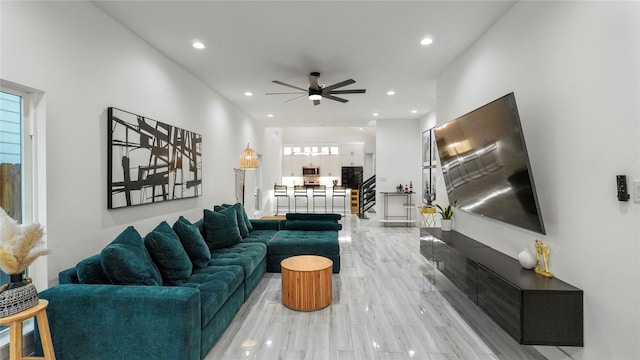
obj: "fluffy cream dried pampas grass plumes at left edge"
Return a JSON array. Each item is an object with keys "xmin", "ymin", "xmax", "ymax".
[{"xmin": 0, "ymin": 208, "xmax": 49, "ymax": 274}]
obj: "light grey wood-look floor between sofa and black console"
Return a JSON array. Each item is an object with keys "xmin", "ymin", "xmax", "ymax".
[{"xmin": 206, "ymin": 214, "xmax": 545, "ymax": 360}]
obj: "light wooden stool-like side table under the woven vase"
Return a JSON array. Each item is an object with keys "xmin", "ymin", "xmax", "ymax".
[{"xmin": 0, "ymin": 299, "xmax": 56, "ymax": 360}]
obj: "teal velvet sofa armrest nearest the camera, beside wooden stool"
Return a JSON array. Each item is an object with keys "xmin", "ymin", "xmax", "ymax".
[{"xmin": 35, "ymin": 284, "xmax": 201, "ymax": 360}]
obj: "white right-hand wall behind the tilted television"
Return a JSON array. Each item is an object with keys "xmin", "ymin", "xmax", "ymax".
[{"xmin": 437, "ymin": 2, "xmax": 640, "ymax": 359}]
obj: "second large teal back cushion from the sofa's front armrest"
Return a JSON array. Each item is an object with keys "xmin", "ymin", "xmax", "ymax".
[{"xmin": 144, "ymin": 221, "xmax": 193, "ymax": 285}]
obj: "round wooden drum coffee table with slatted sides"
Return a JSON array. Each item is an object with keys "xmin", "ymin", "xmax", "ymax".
[{"xmin": 280, "ymin": 255, "xmax": 333, "ymax": 311}]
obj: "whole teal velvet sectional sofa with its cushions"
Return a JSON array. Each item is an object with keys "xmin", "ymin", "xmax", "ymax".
[{"xmin": 34, "ymin": 204, "xmax": 341, "ymax": 360}]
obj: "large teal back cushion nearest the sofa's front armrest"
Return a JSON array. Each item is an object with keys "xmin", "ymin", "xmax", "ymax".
[{"xmin": 100, "ymin": 226, "xmax": 162, "ymax": 286}]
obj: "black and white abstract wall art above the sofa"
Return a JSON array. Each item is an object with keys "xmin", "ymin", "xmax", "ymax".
[{"xmin": 107, "ymin": 107, "xmax": 202, "ymax": 209}]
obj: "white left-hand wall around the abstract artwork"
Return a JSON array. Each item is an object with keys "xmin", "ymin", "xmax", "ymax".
[{"xmin": 0, "ymin": 1, "xmax": 262, "ymax": 290}]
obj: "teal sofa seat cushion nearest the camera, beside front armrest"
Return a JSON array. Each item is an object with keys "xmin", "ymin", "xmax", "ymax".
[{"xmin": 180, "ymin": 265, "xmax": 244, "ymax": 328}]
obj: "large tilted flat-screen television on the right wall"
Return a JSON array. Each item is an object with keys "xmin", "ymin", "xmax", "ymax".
[{"xmin": 434, "ymin": 93, "xmax": 545, "ymax": 234}]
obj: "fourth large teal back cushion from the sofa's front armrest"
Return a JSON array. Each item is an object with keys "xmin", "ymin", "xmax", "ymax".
[{"xmin": 204, "ymin": 207, "xmax": 242, "ymax": 250}]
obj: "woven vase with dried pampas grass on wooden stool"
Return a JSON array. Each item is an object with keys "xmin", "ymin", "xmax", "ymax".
[{"xmin": 0, "ymin": 208, "xmax": 48, "ymax": 317}]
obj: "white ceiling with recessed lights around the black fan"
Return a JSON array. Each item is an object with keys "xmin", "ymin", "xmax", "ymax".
[{"xmin": 93, "ymin": 1, "xmax": 515, "ymax": 127}]
